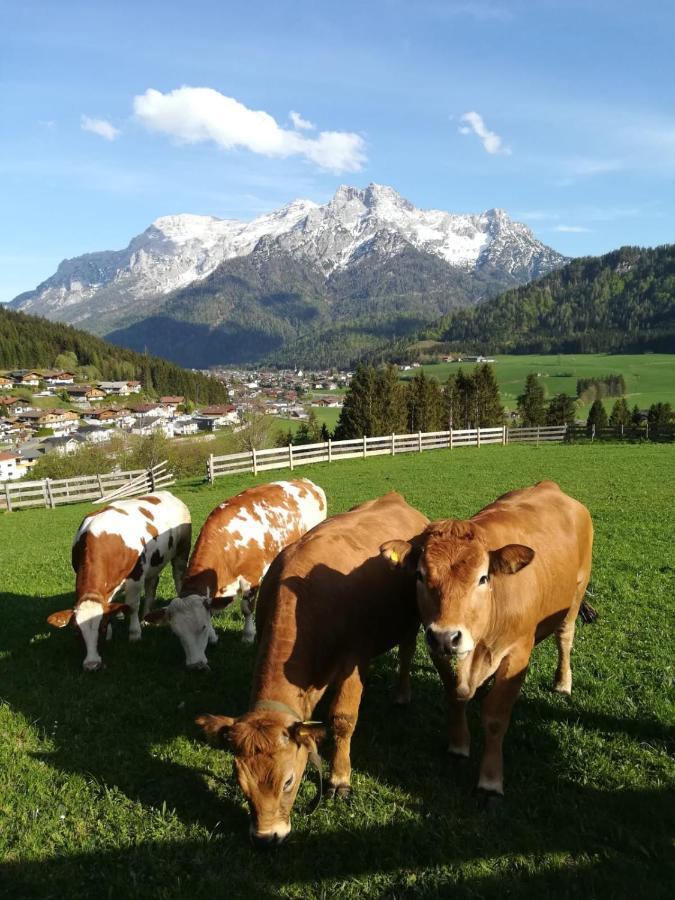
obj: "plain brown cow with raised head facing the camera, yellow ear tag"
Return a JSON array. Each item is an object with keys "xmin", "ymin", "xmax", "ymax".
[{"xmin": 382, "ymin": 481, "xmax": 594, "ymax": 795}]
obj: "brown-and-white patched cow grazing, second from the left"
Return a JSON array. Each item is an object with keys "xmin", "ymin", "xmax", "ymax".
[{"xmin": 146, "ymin": 478, "xmax": 327, "ymax": 669}]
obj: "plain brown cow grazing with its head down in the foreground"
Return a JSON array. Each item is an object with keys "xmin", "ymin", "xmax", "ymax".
[{"xmin": 197, "ymin": 493, "xmax": 428, "ymax": 846}]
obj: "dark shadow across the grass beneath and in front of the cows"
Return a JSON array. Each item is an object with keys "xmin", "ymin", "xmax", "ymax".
[{"xmin": 0, "ymin": 594, "xmax": 675, "ymax": 898}]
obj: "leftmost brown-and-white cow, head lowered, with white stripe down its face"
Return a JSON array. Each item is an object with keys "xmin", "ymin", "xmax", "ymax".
[{"xmin": 47, "ymin": 491, "xmax": 192, "ymax": 671}]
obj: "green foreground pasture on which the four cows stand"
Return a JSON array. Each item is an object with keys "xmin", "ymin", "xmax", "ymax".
[{"xmin": 0, "ymin": 444, "xmax": 675, "ymax": 900}]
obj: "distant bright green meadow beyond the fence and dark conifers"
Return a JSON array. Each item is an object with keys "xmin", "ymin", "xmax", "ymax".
[{"xmin": 403, "ymin": 353, "xmax": 675, "ymax": 418}]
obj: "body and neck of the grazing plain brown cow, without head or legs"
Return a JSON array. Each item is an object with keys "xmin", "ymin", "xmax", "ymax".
[{"xmin": 257, "ymin": 493, "xmax": 428, "ymax": 678}]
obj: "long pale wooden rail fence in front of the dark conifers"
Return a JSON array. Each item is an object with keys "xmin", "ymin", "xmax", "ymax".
[{"xmin": 206, "ymin": 425, "xmax": 567, "ymax": 484}]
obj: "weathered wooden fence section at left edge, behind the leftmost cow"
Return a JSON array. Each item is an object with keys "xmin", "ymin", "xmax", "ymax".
[{"xmin": 0, "ymin": 461, "xmax": 174, "ymax": 512}]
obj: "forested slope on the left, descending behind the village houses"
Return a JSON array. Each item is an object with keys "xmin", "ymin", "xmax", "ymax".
[{"xmin": 0, "ymin": 304, "xmax": 227, "ymax": 403}]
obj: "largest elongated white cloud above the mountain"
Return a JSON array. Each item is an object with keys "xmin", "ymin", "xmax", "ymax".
[{"xmin": 134, "ymin": 87, "xmax": 366, "ymax": 173}]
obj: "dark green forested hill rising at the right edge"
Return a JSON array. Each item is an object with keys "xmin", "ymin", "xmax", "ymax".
[{"xmin": 426, "ymin": 244, "xmax": 675, "ymax": 353}]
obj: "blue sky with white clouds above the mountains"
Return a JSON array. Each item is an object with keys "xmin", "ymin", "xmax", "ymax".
[{"xmin": 0, "ymin": 0, "xmax": 675, "ymax": 300}]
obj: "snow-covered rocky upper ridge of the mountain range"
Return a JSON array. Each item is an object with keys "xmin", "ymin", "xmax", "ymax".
[{"xmin": 12, "ymin": 184, "xmax": 565, "ymax": 331}]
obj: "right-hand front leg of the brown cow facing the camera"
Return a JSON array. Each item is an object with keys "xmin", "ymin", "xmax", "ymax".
[{"xmin": 478, "ymin": 644, "xmax": 532, "ymax": 794}]
